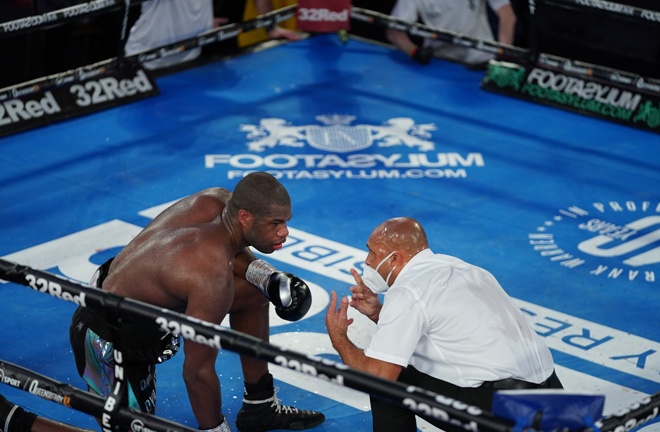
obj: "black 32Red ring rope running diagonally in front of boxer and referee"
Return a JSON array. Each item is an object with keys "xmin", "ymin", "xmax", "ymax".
[{"xmin": 0, "ymin": 259, "xmax": 513, "ymax": 432}]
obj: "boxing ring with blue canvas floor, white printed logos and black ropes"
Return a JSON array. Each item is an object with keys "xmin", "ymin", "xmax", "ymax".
[{"xmin": 0, "ymin": 1, "xmax": 660, "ymax": 432}]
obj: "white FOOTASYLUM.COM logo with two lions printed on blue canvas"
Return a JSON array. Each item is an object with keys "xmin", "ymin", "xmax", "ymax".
[{"xmin": 204, "ymin": 114, "xmax": 485, "ymax": 180}]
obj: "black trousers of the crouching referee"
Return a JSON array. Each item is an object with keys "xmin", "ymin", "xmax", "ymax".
[{"xmin": 369, "ymin": 366, "xmax": 563, "ymax": 432}]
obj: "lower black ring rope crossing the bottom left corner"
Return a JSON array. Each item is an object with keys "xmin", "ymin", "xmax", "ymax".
[{"xmin": 0, "ymin": 359, "xmax": 198, "ymax": 432}]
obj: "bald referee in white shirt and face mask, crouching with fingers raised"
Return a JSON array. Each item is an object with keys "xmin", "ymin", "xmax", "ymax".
[{"xmin": 325, "ymin": 217, "xmax": 562, "ymax": 432}]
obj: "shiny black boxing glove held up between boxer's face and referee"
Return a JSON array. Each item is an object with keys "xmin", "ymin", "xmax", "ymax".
[{"xmin": 264, "ymin": 271, "xmax": 312, "ymax": 321}]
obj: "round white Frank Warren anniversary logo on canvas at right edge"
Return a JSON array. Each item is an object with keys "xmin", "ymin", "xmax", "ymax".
[{"xmin": 529, "ymin": 201, "xmax": 660, "ymax": 283}]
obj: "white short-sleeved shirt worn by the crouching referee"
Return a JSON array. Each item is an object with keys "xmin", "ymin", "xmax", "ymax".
[{"xmin": 365, "ymin": 249, "xmax": 554, "ymax": 387}]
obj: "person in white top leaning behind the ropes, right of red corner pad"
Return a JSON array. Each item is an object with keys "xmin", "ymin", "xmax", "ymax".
[{"xmin": 386, "ymin": 0, "xmax": 516, "ymax": 69}]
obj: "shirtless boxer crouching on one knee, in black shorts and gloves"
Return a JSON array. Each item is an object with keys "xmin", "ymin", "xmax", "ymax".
[{"xmin": 70, "ymin": 172, "xmax": 325, "ymax": 432}]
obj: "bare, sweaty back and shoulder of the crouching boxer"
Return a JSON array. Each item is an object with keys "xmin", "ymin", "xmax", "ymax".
[{"xmin": 103, "ymin": 188, "xmax": 234, "ymax": 310}]
